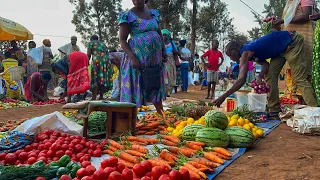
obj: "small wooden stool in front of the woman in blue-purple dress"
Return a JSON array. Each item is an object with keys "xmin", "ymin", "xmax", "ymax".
[{"xmin": 83, "ymin": 101, "xmax": 137, "ymax": 139}]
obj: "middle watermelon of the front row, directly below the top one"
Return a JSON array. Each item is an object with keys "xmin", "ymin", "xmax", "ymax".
[{"xmin": 195, "ymin": 128, "xmax": 229, "ymax": 147}]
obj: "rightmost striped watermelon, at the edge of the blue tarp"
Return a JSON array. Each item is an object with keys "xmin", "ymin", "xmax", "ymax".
[{"xmin": 224, "ymin": 126, "xmax": 254, "ymax": 148}]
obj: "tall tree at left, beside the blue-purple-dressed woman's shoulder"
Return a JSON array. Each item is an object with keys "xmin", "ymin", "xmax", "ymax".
[{"xmin": 69, "ymin": 0, "xmax": 122, "ymax": 49}]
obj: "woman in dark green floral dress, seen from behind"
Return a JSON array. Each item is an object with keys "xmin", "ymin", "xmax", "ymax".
[{"xmin": 87, "ymin": 35, "xmax": 113, "ymax": 100}]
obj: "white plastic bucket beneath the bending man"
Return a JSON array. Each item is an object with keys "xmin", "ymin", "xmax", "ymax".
[{"xmin": 248, "ymin": 93, "xmax": 268, "ymax": 112}]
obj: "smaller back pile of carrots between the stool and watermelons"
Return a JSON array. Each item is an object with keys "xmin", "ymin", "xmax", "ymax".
[{"xmin": 136, "ymin": 112, "xmax": 179, "ymax": 135}]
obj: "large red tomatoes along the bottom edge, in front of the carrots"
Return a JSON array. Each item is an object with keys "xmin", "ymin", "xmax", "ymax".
[{"xmin": 74, "ymin": 157, "xmax": 190, "ymax": 180}]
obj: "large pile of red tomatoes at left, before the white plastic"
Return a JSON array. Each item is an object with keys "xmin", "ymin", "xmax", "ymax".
[{"xmin": 0, "ymin": 130, "xmax": 102, "ymax": 165}]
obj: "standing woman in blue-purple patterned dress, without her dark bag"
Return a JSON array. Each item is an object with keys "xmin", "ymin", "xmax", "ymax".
[{"xmin": 118, "ymin": 0, "xmax": 166, "ymax": 113}]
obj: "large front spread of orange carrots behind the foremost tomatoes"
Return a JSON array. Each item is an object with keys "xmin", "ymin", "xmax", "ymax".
[{"xmin": 103, "ymin": 135, "xmax": 232, "ymax": 179}]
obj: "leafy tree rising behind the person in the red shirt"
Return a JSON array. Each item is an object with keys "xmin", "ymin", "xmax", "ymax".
[{"xmin": 197, "ymin": 0, "xmax": 233, "ymax": 47}]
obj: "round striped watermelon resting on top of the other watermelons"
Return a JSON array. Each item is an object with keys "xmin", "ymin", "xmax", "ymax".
[{"xmin": 204, "ymin": 110, "xmax": 228, "ymax": 130}]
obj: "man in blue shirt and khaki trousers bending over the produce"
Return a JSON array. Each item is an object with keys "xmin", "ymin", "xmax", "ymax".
[{"xmin": 213, "ymin": 31, "xmax": 317, "ymax": 116}]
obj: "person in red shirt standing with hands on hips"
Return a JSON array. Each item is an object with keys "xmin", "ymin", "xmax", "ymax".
[{"xmin": 201, "ymin": 40, "xmax": 224, "ymax": 99}]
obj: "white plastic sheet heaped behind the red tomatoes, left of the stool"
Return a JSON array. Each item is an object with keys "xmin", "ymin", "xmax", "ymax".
[{"xmin": 15, "ymin": 112, "xmax": 83, "ymax": 136}]
